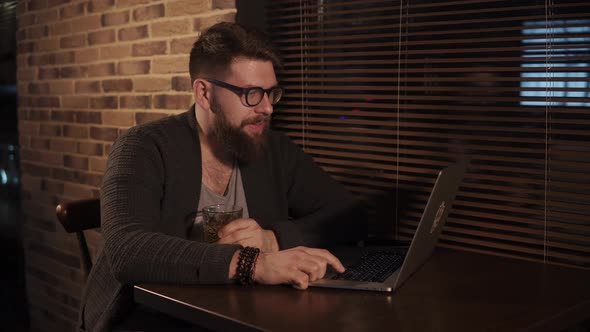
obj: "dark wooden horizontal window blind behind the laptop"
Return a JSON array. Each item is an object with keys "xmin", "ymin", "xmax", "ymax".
[{"xmin": 267, "ymin": 0, "xmax": 590, "ymax": 268}]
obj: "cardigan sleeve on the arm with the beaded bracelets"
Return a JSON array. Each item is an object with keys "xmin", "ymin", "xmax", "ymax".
[{"xmin": 101, "ymin": 129, "xmax": 240, "ymax": 284}]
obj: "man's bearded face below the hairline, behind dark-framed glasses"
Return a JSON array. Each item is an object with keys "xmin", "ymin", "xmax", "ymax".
[{"xmin": 211, "ymin": 58, "xmax": 277, "ymax": 162}]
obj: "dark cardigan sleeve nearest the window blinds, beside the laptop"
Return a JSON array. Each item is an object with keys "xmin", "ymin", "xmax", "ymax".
[{"xmin": 271, "ymin": 136, "xmax": 367, "ymax": 249}]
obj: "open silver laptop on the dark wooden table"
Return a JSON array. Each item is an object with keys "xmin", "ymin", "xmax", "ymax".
[{"xmin": 310, "ymin": 159, "xmax": 469, "ymax": 292}]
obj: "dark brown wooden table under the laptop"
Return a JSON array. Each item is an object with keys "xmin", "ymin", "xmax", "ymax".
[{"xmin": 134, "ymin": 248, "xmax": 590, "ymax": 332}]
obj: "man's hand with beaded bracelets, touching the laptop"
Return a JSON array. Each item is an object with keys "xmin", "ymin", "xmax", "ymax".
[{"xmin": 254, "ymin": 247, "xmax": 344, "ymax": 289}]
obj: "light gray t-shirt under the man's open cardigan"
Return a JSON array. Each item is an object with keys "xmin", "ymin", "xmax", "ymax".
[{"xmin": 189, "ymin": 162, "xmax": 249, "ymax": 241}]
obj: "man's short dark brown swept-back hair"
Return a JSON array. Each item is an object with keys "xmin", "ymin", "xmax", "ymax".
[{"xmin": 189, "ymin": 22, "xmax": 281, "ymax": 82}]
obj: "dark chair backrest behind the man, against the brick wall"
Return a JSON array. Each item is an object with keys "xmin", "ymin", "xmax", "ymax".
[{"xmin": 55, "ymin": 198, "xmax": 100, "ymax": 277}]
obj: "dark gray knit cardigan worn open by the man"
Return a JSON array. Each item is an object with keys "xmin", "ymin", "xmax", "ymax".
[{"xmin": 80, "ymin": 106, "xmax": 366, "ymax": 331}]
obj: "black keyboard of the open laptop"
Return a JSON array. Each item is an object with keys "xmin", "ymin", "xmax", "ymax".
[{"xmin": 332, "ymin": 251, "xmax": 406, "ymax": 282}]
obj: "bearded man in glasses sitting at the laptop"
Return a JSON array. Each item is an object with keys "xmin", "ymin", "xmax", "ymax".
[{"xmin": 80, "ymin": 23, "xmax": 366, "ymax": 331}]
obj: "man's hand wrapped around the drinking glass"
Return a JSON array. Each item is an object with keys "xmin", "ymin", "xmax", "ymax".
[{"xmin": 217, "ymin": 219, "xmax": 279, "ymax": 253}]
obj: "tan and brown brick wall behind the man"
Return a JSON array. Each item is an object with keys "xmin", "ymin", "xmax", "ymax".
[{"xmin": 17, "ymin": 0, "xmax": 236, "ymax": 331}]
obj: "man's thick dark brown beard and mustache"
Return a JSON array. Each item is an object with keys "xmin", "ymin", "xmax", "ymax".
[{"xmin": 211, "ymin": 101, "xmax": 270, "ymax": 162}]
